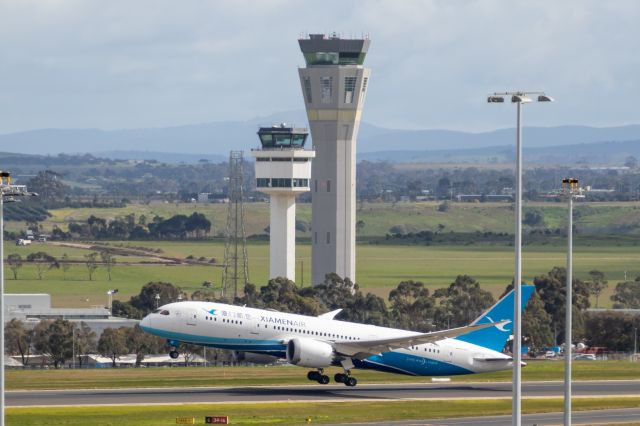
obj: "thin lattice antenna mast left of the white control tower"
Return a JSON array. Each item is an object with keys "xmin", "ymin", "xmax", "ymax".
[{"xmin": 222, "ymin": 151, "xmax": 249, "ymax": 299}]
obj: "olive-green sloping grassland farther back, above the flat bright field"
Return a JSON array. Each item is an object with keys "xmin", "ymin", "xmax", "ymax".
[{"xmin": 6, "ymin": 202, "xmax": 640, "ymax": 237}]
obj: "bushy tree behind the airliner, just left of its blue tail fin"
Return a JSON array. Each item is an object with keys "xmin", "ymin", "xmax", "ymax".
[{"xmin": 433, "ymin": 275, "xmax": 495, "ymax": 328}]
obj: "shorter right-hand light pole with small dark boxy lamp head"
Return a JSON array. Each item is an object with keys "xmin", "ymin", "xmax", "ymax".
[{"xmin": 562, "ymin": 178, "xmax": 582, "ymax": 426}]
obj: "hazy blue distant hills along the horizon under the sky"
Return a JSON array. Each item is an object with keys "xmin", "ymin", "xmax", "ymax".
[{"xmin": 0, "ymin": 111, "xmax": 640, "ymax": 162}]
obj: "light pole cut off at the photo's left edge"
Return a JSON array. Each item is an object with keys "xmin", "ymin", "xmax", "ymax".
[{"xmin": 0, "ymin": 171, "xmax": 38, "ymax": 426}]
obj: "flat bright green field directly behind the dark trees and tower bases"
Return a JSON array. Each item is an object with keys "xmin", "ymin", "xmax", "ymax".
[{"xmin": 5, "ymin": 241, "xmax": 640, "ymax": 307}]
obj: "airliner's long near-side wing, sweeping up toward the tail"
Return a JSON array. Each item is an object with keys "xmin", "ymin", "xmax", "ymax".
[{"xmin": 333, "ymin": 321, "xmax": 508, "ymax": 359}]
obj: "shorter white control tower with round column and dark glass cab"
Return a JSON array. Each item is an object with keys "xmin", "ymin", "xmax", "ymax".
[{"xmin": 251, "ymin": 124, "xmax": 315, "ymax": 281}]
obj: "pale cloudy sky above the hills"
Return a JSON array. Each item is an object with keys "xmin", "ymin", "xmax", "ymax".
[{"xmin": 0, "ymin": 0, "xmax": 640, "ymax": 133}]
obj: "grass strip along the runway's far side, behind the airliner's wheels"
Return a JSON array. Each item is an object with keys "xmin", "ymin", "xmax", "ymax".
[{"xmin": 6, "ymin": 361, "xmax": 640, "ymax": 390}]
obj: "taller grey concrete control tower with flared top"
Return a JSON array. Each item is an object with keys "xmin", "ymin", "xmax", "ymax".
[{"xmin": 298, "ymin": 34, "xmax": 371, "ymax": 284}]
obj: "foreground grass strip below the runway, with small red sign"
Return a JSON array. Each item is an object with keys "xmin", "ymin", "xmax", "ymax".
[{"xmin": 7, "ymin": 397, "xmax": 640, "ymax": 426}]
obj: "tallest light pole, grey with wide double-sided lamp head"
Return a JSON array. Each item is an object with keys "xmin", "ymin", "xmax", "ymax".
[{"xmin": 487, "ymin": 92, "xmax": 553, "ymax": 426}]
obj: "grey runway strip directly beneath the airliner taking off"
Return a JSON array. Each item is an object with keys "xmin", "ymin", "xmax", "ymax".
[{"xmin": 6, "ymin": 380, "xmax": 640, "ymax": 407}]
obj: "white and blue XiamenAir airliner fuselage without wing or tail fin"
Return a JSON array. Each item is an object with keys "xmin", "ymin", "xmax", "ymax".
[{"xmin": 140, "ymin": 302, "xmax": 512, "ymax": 376}]
